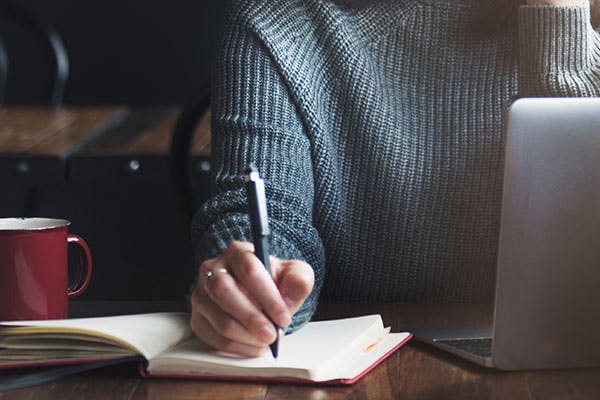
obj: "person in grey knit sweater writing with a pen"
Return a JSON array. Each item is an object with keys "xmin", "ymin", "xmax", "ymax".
[{"xmin": 190, "ymin": 0, "xmax": 600, "ymax": 356}]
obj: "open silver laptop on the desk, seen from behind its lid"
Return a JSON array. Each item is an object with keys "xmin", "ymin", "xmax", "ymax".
[{"xmin": 413, "ymin": 98, "xmax": 600, "ymax": 370}]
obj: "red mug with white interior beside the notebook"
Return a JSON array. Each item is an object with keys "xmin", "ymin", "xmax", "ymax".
[{"xmin": 0, "ymin": 218, "xmax": 92, "ymax": 321}]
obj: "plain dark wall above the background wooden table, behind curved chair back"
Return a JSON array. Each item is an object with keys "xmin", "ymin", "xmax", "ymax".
[{"xmin": 0, "ymin": 0, "xmax": 223, "ymax": 105}]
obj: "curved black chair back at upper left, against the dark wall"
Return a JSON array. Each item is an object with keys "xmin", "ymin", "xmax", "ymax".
[{"xmin": 0, "ymin": 3, "xmax": 69, "ymax": 106}]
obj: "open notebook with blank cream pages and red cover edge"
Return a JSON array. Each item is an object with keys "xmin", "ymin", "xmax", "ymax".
[{"xmin": 0, "ymin": 313, "xmax": 411, "ymax": 384}]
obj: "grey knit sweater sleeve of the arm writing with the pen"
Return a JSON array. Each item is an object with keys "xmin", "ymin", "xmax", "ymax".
[{"xmin": 192, "ymin": 3, "xmax": 324, "ymax": 331}]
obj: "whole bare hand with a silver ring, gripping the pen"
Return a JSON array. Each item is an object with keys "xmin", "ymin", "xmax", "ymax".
[{"xmin": 190, "ymin": 242, "xmax": 314, "ymax": 357}]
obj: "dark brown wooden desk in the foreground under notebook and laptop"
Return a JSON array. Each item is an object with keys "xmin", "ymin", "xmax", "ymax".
[{"xmin": 0, "ymin": 303, "xmax": 600, "ymax": 400}]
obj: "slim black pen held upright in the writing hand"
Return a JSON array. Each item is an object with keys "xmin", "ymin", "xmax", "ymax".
[{"xmin": 244, "ymin": 165, "xmax": 279, "ymax": 358}]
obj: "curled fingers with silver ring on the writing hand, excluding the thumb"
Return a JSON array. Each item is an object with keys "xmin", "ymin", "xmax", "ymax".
[{"xmin": 191, "ymin": 243, "xmax": 284, "ymax": 356}]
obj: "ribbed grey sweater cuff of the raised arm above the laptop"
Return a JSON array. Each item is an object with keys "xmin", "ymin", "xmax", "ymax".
[{"xmin": 519, "ymin": 5, "xmax": 600, "ymax": 96}]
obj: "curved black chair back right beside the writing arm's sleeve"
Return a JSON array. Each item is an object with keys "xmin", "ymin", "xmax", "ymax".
[{"xmin": 168, "ymin": 88, "xmax": 210, "ymax": 238}]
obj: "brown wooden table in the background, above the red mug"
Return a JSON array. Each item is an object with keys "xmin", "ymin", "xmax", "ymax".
[{"xmin": 0, "ymin": 106, "xmax": 210, "ymax": 191}]
